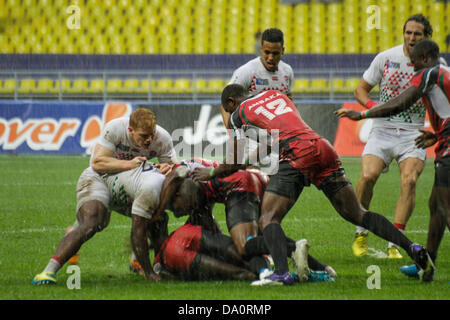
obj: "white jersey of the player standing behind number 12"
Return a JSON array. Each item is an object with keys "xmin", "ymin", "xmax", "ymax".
[{"xmin": 228, "ymin": 57, "xmax": 294, "ymax": 95}]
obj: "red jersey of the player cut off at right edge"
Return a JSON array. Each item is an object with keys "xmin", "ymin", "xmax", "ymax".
[{"xmin": 411, "ymin": 65, "xmax": 450, "ymax": 158}]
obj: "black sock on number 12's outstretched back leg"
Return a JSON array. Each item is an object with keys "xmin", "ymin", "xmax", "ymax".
[{"xmin": 361, "ymin": 211, "xmax": 412, "ymax": 255}]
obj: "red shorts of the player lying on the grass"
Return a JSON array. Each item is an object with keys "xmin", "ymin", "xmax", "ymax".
[{"xmin": 155, "ymin": 224, "xmax": 202, "ymax": 271}]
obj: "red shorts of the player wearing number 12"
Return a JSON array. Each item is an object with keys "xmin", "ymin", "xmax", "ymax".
[{"xmin": 289, "ymin": 138, "xmax": 342, "ymax": 187}]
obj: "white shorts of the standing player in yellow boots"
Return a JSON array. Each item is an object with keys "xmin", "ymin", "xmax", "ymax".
[{"xmin": 362, "ymin": 127, "xmax": 427, "ymax": 167}]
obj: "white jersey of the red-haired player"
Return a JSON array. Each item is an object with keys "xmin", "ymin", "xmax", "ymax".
[{"xmin": 91, "ymin": 117, "xmax": 176, "ymax": 163}]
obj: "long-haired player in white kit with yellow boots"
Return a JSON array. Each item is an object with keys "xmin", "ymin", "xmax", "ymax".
[{"xmin": 352, "ymin": 14, "xmax": 433, "ymax": 259}]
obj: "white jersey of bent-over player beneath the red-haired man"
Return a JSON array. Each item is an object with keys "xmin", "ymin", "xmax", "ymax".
[{"xmin": 102, "ymin": 161, "xmax": 165, "ymax": 219}]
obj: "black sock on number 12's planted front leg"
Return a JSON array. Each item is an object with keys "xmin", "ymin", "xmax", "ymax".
[{"xmin": 263, "ymin": 223, "xmax": 289, "ymax": 274}]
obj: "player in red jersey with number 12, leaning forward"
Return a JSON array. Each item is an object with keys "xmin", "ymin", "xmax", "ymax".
[{"xmin": 193, "ymin": 85, "xmax": 432, "ymax": 285}]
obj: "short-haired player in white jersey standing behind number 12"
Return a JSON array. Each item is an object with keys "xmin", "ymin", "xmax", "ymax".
[{"xmin": 220, "ymin": 28, "xmax": 294, "ymax": 128}]
